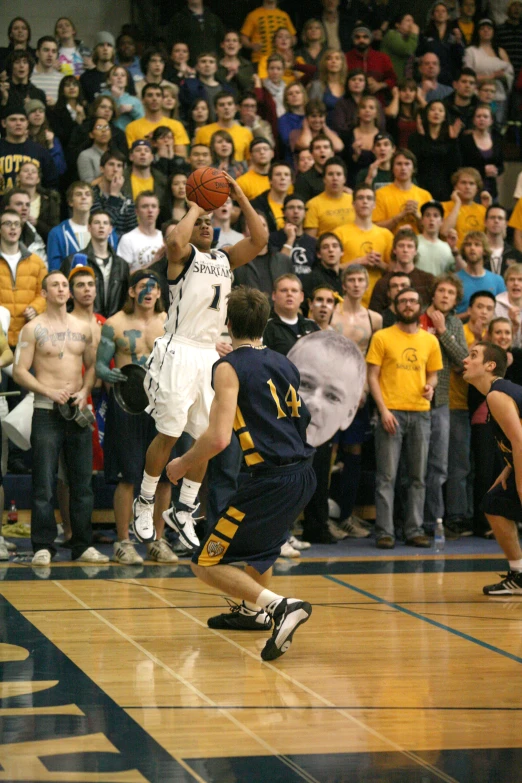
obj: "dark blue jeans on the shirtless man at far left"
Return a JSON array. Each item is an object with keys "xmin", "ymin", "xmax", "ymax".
[{"xmin": 31, "ymin": 408, "xmax": 93, "ymax": 560}]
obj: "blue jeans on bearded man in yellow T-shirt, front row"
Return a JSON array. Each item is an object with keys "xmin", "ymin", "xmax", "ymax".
[{"xmin": 375, "ymin": 410, "xmax": 431, "ymax": 540}]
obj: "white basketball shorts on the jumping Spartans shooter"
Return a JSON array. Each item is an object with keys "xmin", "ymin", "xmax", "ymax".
[{"xmin": 144, "ymin": 334, "xmax": 219, "ymax": 438}]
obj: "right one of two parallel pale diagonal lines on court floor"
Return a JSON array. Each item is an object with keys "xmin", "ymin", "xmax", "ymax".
[{"xmin": 134, "ymin": 586, "xmax": 459, "ymax": 783}]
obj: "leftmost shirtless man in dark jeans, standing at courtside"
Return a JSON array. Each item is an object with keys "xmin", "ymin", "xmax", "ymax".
[{"xmin": 13, "ymin": 270, "xmax": 105, "ymax": 566}]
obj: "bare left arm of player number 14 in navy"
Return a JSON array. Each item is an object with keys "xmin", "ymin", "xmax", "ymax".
[{"xmin": 167, "ymin": 362, "xmax": 239, "ymax": 484}]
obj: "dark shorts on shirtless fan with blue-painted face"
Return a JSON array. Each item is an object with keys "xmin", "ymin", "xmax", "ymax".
[{"xmin": 104, "ymin": 389, "xmax": 168, "ymax": 485}]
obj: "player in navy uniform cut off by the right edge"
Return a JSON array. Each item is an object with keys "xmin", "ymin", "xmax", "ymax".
[{"xmin": 462, "ymin": 342, "xmax": 522, "ymax": 595}]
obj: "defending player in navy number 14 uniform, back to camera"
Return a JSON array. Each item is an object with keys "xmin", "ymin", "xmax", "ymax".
[{"xmin": 167, "ymin": 286, "xmax": 315, "ymax": 661}]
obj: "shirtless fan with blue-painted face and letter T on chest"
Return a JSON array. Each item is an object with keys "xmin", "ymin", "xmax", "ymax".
[{"xmin": 96, "ymin": 269, "xmax": 177, "ymax": 565}]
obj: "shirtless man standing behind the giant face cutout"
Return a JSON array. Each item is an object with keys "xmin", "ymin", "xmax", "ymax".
[{"xmin": 332, "ymin": 264, "xmax": 382, "ymax": 355}]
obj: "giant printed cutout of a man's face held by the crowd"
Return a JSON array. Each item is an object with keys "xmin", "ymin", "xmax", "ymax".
[{"xmin": 288, "ymin": 329, "xmax": 366, "ymax": 446}]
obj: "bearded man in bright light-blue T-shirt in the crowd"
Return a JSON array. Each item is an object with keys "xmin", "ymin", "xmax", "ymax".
[{"xmin": 457, "ymin": 231, "xmax": 506, "ymax": 319}]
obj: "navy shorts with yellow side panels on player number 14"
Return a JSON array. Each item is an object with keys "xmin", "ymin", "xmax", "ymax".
[{"xmin": 192, "ymin": 458, "xmax": 316, "ymax": 574}]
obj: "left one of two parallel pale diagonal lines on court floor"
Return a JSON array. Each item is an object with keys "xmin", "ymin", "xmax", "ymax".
[{"xmin": 52, "ymin": 580, "xmax": 320, "ymax": 783}]
